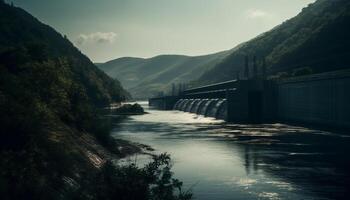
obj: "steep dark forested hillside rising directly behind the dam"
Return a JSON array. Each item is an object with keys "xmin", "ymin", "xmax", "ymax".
[{"xmin": 198, "ymin": 0, "xmax": 350, "ymax": 84}]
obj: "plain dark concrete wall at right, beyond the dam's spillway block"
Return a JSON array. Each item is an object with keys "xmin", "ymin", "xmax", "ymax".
[{"xmin": 277, "ymin": 71, "xmax": 350, "ymax": 129}]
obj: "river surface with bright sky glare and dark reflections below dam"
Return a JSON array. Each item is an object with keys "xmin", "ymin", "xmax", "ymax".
[{"xmin": 113, "ymin": 102, "xmax": 350, "ymax": 199}]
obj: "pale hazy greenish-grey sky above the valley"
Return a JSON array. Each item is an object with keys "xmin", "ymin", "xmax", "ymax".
[{"xmin": 13, "ymin": 0, "xmax": 315, "ymax": 62}]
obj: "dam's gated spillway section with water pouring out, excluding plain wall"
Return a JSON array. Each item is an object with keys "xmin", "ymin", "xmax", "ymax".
[{"xmin": 149, "ymin": 80, "xmax": 275, "ymax": 123}]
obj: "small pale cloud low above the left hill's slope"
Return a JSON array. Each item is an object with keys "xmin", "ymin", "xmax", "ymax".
[{"xmin": 75, "ymin": 32, "xmax": 117, "ymax": 45}]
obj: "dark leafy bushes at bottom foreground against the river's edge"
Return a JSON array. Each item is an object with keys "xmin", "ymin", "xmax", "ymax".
[{"xmin": 77, "ymin": 154, "xmax": 192, "ymax": 200}]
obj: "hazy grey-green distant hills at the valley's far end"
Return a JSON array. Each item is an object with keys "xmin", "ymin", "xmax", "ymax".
[{"xmin": 98, "ymin": 50, "xmax": 232, "ymax": 99}]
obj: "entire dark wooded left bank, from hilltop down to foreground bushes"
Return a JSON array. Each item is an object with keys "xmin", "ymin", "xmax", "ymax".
[{"xmin": 0, "ymin": 0, "xmax": 192, "ymax": 200}]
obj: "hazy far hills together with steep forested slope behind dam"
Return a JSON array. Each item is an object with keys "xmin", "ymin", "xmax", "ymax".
[{"xmin": 98, "ymin": 0, "xmax": 350, "ymax": 98}]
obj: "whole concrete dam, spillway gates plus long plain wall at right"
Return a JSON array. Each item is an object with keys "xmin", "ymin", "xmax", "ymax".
[{"xmin": 149, "ymin": 70, "xmax": 350, "ymax": 130}]
